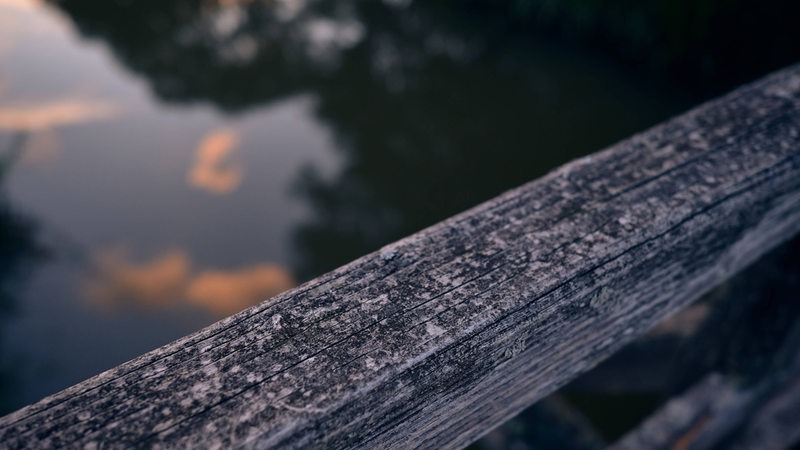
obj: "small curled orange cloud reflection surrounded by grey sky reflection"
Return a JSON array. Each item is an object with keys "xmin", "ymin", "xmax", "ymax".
[{"xmin": 187, "ymin": 130, "xmax": 244, "ymax": 195}]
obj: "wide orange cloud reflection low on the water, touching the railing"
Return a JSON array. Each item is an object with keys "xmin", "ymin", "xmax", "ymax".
[{"xmin": 81, "ymin": 247, "xmax": 296, "ymax": 318}]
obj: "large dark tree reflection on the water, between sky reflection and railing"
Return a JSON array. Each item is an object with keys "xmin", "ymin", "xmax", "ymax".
[{"xmin": 45, "ymin": 0, "xmax": 792, "ymax": 279}]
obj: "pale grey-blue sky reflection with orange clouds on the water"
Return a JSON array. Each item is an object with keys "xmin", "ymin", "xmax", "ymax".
[{"xmin": 0, "ymin": 0, "xmax": 341, "ymax": 413}]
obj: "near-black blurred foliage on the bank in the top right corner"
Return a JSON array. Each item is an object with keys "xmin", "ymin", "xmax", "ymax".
[{"xmin": 460, "ymin": 0, "xmax": 800, "ymax": 95}]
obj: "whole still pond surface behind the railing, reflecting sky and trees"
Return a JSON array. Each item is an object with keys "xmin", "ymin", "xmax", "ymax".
[{"xmin": 0, "ymin": 0, "xmax": 691, "ymax": 412}]
